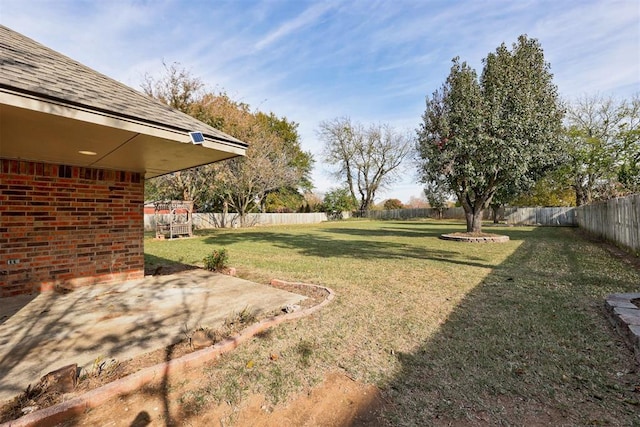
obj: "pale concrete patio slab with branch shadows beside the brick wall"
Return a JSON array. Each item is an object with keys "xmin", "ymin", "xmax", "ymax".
[{"xmin": 0, "ymin": 270, "xmax": 305, "ymax": 402}]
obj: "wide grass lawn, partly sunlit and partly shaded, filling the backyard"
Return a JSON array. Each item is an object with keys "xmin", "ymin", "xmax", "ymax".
[{"xmin": 145, "ymin": 220, "xmax": 640, "ymax": 426}]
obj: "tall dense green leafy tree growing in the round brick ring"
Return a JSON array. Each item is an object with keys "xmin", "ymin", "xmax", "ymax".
[{"xmin": 417, "ymin": 36, "xmax": 563, "ymax": 232}]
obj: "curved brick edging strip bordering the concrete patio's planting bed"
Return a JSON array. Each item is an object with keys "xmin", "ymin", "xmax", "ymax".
[{"xmin": 0, "ymin": 279, "xmax": 335, "ymax": 427}]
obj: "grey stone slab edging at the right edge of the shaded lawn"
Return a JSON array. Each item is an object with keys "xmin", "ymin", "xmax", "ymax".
[{"xmin": 605, "ymin": 293, "xmax": 640, "ymax": 363}]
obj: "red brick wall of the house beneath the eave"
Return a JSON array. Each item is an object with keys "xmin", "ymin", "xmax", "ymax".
[{"xmin": 0, "ymin": 159, "xmax": 144, "ymax": 297}]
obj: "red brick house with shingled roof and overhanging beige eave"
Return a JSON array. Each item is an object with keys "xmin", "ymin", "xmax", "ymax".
[{"xmin": 0, "ymin": 26, "xmax": 246, "ymax": 297}]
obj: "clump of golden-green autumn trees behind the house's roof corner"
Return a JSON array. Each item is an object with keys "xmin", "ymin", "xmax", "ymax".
[{"xmin": 143, "ymin": 64, "xmax": 313, "ymax": 224}]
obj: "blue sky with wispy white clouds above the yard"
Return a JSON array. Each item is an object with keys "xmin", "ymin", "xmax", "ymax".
[{"xmin": 0, "ymin": 0, "xmax": 640, "ymax": 202}]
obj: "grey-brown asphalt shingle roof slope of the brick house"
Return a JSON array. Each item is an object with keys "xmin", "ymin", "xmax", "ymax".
[{"xmin": 0, "ymin": 25, "xmax": 246, "ymax": 146}]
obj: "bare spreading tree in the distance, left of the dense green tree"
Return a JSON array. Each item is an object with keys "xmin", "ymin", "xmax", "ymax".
[{"xmin": 318, "ymin": 117, "xmax": 413, "ymax": 210}]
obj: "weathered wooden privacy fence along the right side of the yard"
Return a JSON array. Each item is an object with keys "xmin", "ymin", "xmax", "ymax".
[{"xmin": 576, "ymin": 194, "xmax": 640, "ymax": 254}]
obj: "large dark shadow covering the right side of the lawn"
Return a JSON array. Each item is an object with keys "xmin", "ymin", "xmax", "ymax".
[{"xmin": 364, "ymin": 229, "xmax": 640, "ymax": 426}]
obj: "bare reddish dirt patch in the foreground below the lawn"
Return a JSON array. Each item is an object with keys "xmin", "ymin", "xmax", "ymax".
[{"xmin": 61, "ymin": 370, "xmax": 382, "ymax": 427}]
